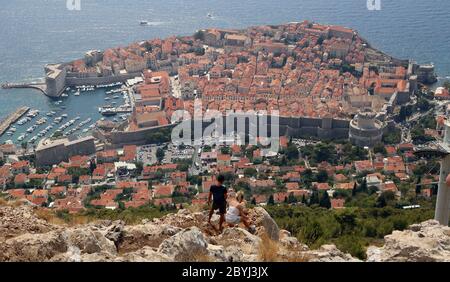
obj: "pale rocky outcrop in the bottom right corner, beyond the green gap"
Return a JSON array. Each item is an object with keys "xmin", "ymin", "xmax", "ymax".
[{"xmin": 367, "ymin": 220, "xmax": 450, "ymax": 262}]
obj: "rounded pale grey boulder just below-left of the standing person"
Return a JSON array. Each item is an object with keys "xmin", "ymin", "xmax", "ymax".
[{"xmin": 158, "ymin": 227, "xmax": 208, "ymax": 261}]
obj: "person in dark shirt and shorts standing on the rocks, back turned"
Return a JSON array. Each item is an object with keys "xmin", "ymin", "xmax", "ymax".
[{"xmin": 208, "ymin": 175, "xmax": 227, "ymax": 231}]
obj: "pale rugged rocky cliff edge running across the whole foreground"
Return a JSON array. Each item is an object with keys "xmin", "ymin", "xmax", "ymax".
[{"xmin": 0, "ymin": 205, "xmax": 450, "ymax": 262}]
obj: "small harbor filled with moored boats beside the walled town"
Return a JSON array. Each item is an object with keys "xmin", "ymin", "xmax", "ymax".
[{"xmin": 0, "ymin": 83, "xmax": 132, "ymax": 146}]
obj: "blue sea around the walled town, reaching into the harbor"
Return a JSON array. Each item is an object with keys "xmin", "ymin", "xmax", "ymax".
[{"xmin": 0, "ymin": 0, "xmax": 450, "ymax": 143}]
